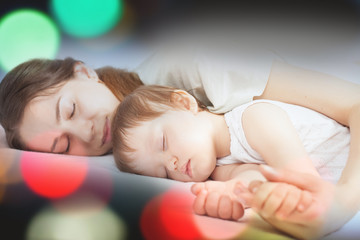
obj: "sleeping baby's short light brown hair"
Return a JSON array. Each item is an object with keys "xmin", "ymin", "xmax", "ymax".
[{"xmin": 111, "ymin": 85, "xmax": 207, "ymax": 174}]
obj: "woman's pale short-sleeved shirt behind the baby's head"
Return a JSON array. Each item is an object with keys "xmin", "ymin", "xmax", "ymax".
[{"xmin": 134, "ymin": 49, "xmax": 282, "ymax": 113}]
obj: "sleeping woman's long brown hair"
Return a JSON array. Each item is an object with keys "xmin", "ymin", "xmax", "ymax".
[{"xmin": 0, "ymin": 58, "xmax": 143, "ymax": 149}]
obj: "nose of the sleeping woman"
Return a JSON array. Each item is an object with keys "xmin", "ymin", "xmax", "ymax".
[{"xmin": 68, "ymin": 119, "xmax": 95, "ymax": 143}]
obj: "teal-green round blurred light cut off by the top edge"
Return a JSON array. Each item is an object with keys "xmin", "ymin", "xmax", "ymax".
[{"xmin": 50, "ymin": 0, "xmax": 123, "ymax": 38}]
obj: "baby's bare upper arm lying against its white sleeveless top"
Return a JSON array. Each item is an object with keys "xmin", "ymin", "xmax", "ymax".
[{"xmin": 239, "ymin": 103, "xmax": 320, "ymax": 177}]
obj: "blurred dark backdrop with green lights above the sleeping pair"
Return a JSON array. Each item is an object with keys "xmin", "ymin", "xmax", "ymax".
[{"xmin": 0, "ymin": 0, "xmax": 360, "ymax": 78}]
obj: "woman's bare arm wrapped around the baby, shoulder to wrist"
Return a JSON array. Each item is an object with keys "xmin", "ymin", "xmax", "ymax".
[{"xmin": 255, "ymin": 62, "xmax": 360, "ymax": 237}]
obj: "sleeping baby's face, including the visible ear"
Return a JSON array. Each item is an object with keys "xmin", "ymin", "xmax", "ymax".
[{"xmin": 122, "ymin": 110, "xmax": 216, "ymax": 182}]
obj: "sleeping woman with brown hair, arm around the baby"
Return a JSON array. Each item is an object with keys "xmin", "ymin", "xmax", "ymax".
[{"xmin": 0, "ymin": 49, "xmax": 360, "ymax": 237}]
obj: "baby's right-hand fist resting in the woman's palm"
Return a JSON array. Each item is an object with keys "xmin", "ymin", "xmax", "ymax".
[{"xmin": 236, "ymin": 181, "xmax": 312, "ymax": 220}]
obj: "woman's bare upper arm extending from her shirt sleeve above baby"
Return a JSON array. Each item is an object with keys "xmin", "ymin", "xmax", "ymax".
[{"xmin": 255, "ymin": 61, "xmax": 360, "ymax": 127}]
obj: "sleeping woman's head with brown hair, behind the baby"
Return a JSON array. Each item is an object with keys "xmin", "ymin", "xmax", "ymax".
[{"xmin": 0, "ymin": 58, "xmax": 142, "ymax": 155}]
